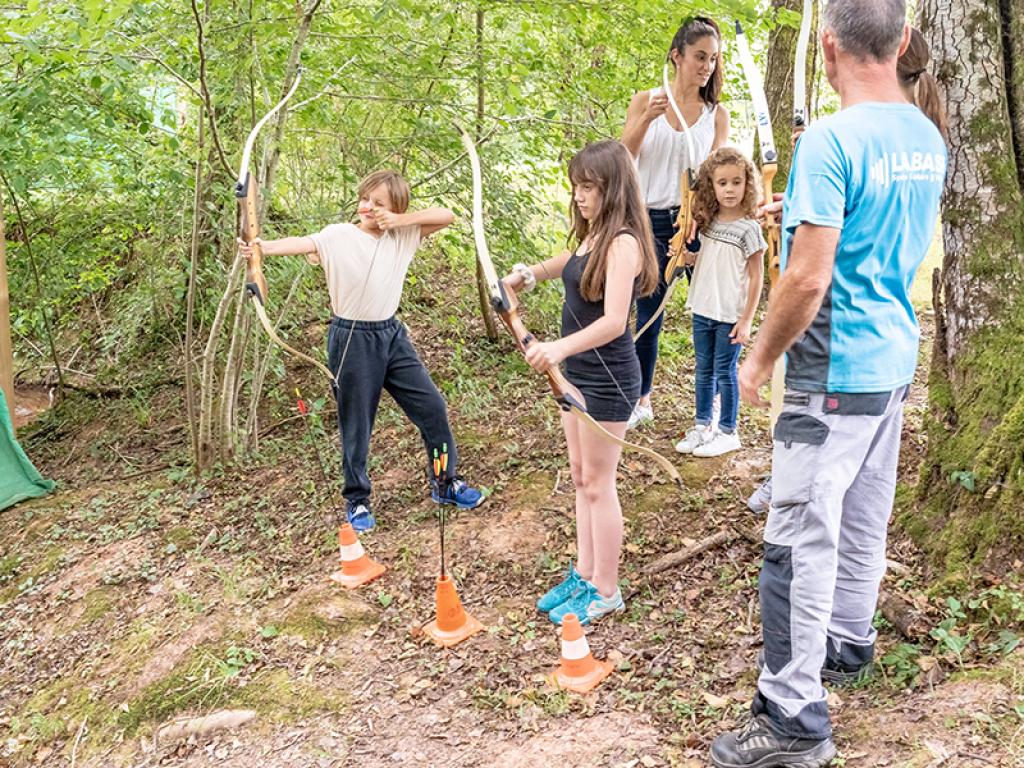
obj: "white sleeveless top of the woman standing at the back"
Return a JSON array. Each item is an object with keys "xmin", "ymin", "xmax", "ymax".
[{"xmin": 636, "ymin": 94, "xmax": 715, "ymax": 214}]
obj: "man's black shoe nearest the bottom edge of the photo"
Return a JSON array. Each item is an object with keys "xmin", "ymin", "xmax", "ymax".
[{"xmin": 711, "ymin": 715, "xmax": 836, "ymax": 768}]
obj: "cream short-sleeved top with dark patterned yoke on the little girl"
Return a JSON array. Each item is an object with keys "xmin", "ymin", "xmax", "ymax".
[{"xmin": 686, "ymin": 219, "xmax": 768, "ymax": 323}]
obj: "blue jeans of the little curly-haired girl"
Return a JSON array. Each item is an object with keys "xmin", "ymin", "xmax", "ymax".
[{"xmin": 693, "ymin": 314, "xmax": 742, "ymax": 432}]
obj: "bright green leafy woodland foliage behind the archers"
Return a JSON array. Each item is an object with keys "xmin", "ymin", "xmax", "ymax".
[{"xmin": 0, "ymin": 0, "xmax": 770, "ymax": 378}]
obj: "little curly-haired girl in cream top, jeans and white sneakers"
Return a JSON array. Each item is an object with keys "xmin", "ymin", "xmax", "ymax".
[{"xmin": 676, "ymin": 147, "xmax": 767, "ymax": 457}]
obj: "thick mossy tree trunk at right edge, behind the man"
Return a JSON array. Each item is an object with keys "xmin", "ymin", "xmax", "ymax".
[{"xmin": 903, "ymin": 0, "xmax": 1024, "ymax": 571}]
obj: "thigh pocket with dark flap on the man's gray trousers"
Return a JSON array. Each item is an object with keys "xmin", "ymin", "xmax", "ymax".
[{"xmin": 771, "ymin": 411, "xmax": 829, "ymax": 508}]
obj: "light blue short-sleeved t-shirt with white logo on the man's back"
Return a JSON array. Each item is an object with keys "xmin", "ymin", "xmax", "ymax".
[{"xmin": 781, "ymin": 102, "xmax": 946, "ymax": 392}]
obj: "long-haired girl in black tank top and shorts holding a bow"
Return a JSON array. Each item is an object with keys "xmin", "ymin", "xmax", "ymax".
[{"xmin": 505, "ymin": 141, "xmax": 657, "ymax": 624}]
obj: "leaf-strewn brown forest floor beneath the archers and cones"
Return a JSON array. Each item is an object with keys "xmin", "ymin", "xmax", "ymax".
[{"xmin": 0, "ymin": 270, "xmax": 1024, "ymax": 768}]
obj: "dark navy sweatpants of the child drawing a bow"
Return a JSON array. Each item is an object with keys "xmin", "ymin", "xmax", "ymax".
[{"xmin": 328, "ymin": 317, "xmax": 458, "ymax": 504}]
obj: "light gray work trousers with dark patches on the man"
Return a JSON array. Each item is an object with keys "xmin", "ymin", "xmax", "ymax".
[{"xmin": 753, "ymin": 387, "xmax": 908, "ymax": 739}]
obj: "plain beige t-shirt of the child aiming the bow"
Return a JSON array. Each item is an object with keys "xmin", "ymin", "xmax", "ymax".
[{"xmin": 309, "ymin": 223, "xmax": 420, "ymax": 321}]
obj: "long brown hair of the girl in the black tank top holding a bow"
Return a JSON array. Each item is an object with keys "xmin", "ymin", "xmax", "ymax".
[{"xmin": 569, "ymin": 139, "xmax": 657, "ymax": 301}]
